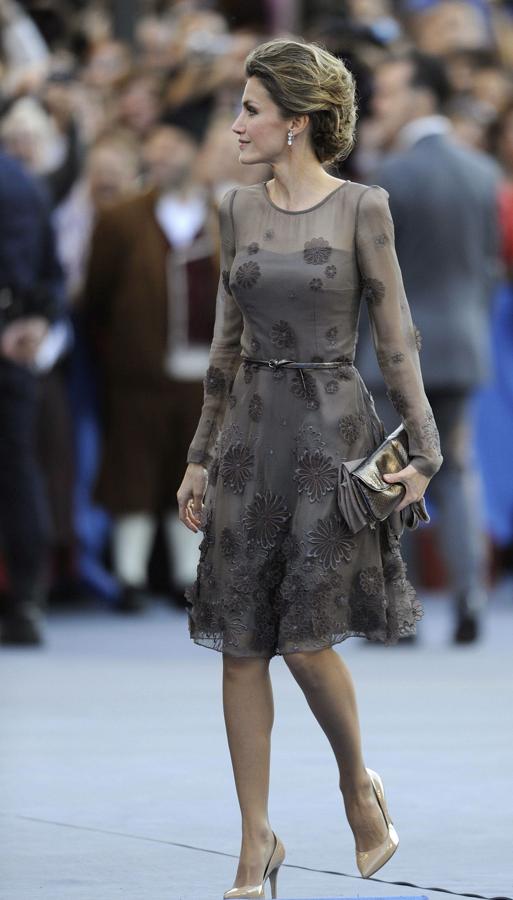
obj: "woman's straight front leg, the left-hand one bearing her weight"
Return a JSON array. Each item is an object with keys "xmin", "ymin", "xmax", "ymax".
[{"xmin": 223, "ymin": 653, "xmax": 274, "ymax": 887}]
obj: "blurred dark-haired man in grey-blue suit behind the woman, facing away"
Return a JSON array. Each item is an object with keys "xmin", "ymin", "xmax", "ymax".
[{"xmin": 358, "ymin": 53, "xmax": 499, "ymax": 643}]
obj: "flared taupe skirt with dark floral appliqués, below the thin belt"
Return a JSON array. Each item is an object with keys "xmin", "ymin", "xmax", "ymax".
[{"xmin": 185, "ymin": 363, "xmax": 422, "ymax": 657}]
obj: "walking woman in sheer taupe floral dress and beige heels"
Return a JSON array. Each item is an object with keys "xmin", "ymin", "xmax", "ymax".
[{"xmin": 177, "ymin": 40, "xmax": 442, "ymax": 898}]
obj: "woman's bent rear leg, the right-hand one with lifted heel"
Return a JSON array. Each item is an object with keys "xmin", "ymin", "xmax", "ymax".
[{"xmin": 284, "ymin": 647, "xmax": 387, "ymax": 850}]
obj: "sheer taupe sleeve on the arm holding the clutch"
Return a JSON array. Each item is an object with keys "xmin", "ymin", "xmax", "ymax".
[{"xmin": 356, "ymin": 186, "xmax": 443, "ymax": 478}]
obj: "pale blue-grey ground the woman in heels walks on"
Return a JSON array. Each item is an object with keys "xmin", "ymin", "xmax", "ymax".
[{"xmin": 0, "ymin": 583, "xmax": 513, "ymax": 900}]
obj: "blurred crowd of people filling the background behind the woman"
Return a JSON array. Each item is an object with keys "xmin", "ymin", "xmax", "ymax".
[{"xmin": 0, "ymin": 0, "xmax": 513, "ymax": 644}]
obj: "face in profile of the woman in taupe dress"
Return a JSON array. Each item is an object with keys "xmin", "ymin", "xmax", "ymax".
[{"xmin": 232, "ymin": 76, "xmax": 290, "ymax": 164}]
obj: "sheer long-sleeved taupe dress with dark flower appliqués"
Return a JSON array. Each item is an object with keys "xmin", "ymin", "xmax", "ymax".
[{"xmin": 185, "ymin": 181, "xmax": 442, "ymax": 657}]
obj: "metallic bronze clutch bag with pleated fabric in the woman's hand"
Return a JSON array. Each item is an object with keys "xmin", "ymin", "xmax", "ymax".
[{"xmin": 338, "ymin": 425, "xmax": 430, "ymax": 535}]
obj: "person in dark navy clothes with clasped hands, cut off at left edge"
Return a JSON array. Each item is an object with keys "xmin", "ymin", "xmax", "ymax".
[{"xmin": 0, "ymin": 151, "xmax": 63, "ymax": 644}]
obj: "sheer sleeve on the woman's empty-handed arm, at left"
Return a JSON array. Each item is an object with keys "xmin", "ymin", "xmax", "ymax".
[{"xmin": 187, "ymin": 188, "xmax": 243, "ymax": 466}]
